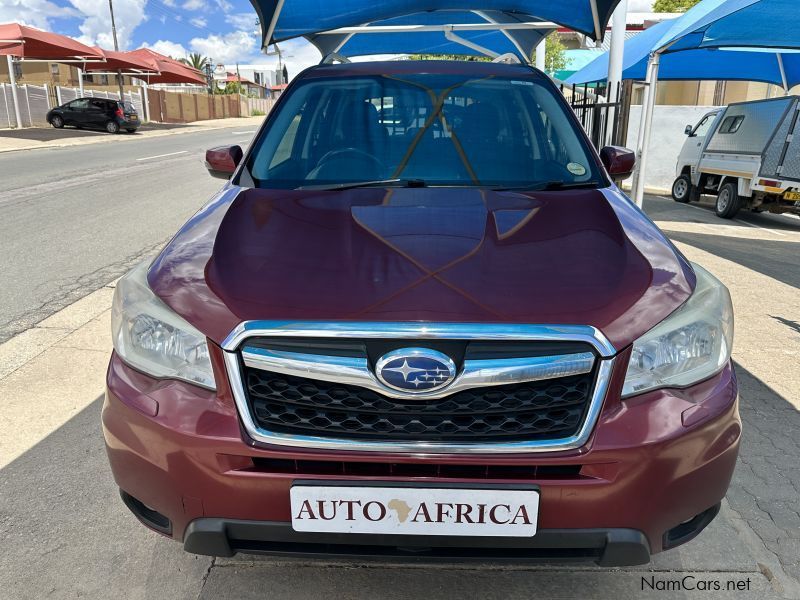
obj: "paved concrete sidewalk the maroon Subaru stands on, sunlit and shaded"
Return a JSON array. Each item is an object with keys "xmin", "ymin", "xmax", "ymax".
[{"xmin": 0, "ymin": 202, "xmax": 800, "ymax": 600}]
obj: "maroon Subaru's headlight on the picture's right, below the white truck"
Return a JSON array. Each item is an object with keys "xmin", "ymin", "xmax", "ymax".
[{"xmin": 622, "ymin": 264, "xmax": 733, "ymax": 397}]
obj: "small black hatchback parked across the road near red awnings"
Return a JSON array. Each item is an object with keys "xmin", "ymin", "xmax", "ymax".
[{"xmin": 47, "ymin": 98, "xmax": 141, "ymax": 133}]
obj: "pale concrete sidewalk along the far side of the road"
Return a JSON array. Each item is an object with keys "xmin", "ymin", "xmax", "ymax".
[{"xmin": 0, "ymin": 116, "xmax": 264, "ymax": 152}]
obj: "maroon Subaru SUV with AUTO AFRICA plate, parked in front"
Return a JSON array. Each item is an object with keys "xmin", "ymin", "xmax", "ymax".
[{"xmin": 103, "ymin": 61, "xmax": 741, "ymax": 566}]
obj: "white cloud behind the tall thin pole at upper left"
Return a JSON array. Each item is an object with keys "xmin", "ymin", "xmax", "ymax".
[{"xmin": 70, "ymin": 0, "xmax": 147, "ymax": 50}]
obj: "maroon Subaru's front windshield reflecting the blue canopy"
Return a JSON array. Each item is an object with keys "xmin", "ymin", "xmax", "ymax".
[{"xmin": 248, "ymin": 74, "xmax": 603, "ymax": 189}]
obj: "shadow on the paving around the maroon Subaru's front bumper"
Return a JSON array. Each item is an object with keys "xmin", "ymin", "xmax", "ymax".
[{"xmin": 0, "ymin": 358, "xmax": 800, "ymax": 600}]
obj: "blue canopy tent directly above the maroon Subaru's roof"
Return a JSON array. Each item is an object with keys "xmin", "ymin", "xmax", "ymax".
[{"xmin": 251, "ymin": 0, "xmax": 632, "ymax": 61}]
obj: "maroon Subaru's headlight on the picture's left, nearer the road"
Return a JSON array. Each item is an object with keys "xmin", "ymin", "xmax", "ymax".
[{"xmin": 111, "ymin": 262, "xmax": 216, "ymax": 390}]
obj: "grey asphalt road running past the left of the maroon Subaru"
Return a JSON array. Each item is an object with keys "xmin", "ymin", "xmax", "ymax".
[{"xmin": 0, "ymin": 126, "xmax": 254, "ymax": 342}]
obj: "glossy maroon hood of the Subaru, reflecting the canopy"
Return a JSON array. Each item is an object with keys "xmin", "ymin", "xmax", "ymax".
[{"xmin": 148, "ymin": 186, "xmax": 695, "ymax": 349}]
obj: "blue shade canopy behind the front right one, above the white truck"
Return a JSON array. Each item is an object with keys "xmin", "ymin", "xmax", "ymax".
[{"xmin": 567, "ymin": 19, "xmax": 800, "ymax": 87}]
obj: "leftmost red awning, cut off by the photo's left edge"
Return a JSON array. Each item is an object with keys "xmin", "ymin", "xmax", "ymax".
[{"xmin": 0, "ymin": 23, "xmax": 103, "ymax": 62}]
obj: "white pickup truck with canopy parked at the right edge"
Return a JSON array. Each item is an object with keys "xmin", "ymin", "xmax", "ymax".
[{"xmin": 672, "ymin": 96, "xmax": 800, "ymax": 219}]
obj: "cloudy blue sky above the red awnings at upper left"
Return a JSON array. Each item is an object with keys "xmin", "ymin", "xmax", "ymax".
[{"xmin": 0, "ymin": 0, "xmax": 320, "ymax": 74}]
